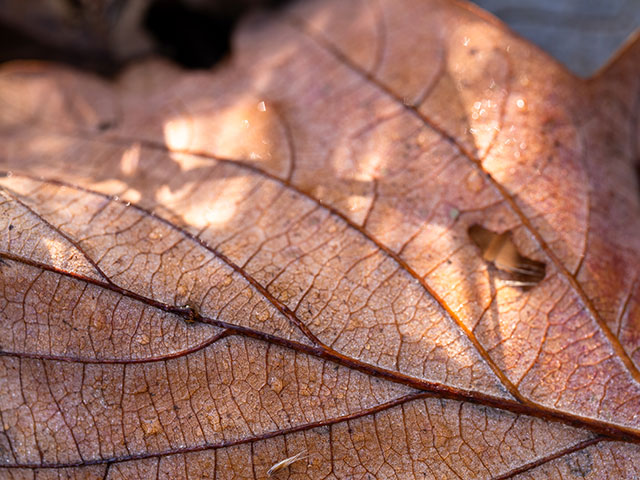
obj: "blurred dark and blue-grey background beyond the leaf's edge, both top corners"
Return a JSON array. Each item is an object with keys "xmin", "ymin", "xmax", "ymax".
[{"xmin": 0, "ymin": 0, "xmax": 640, "ymax": 77}]
